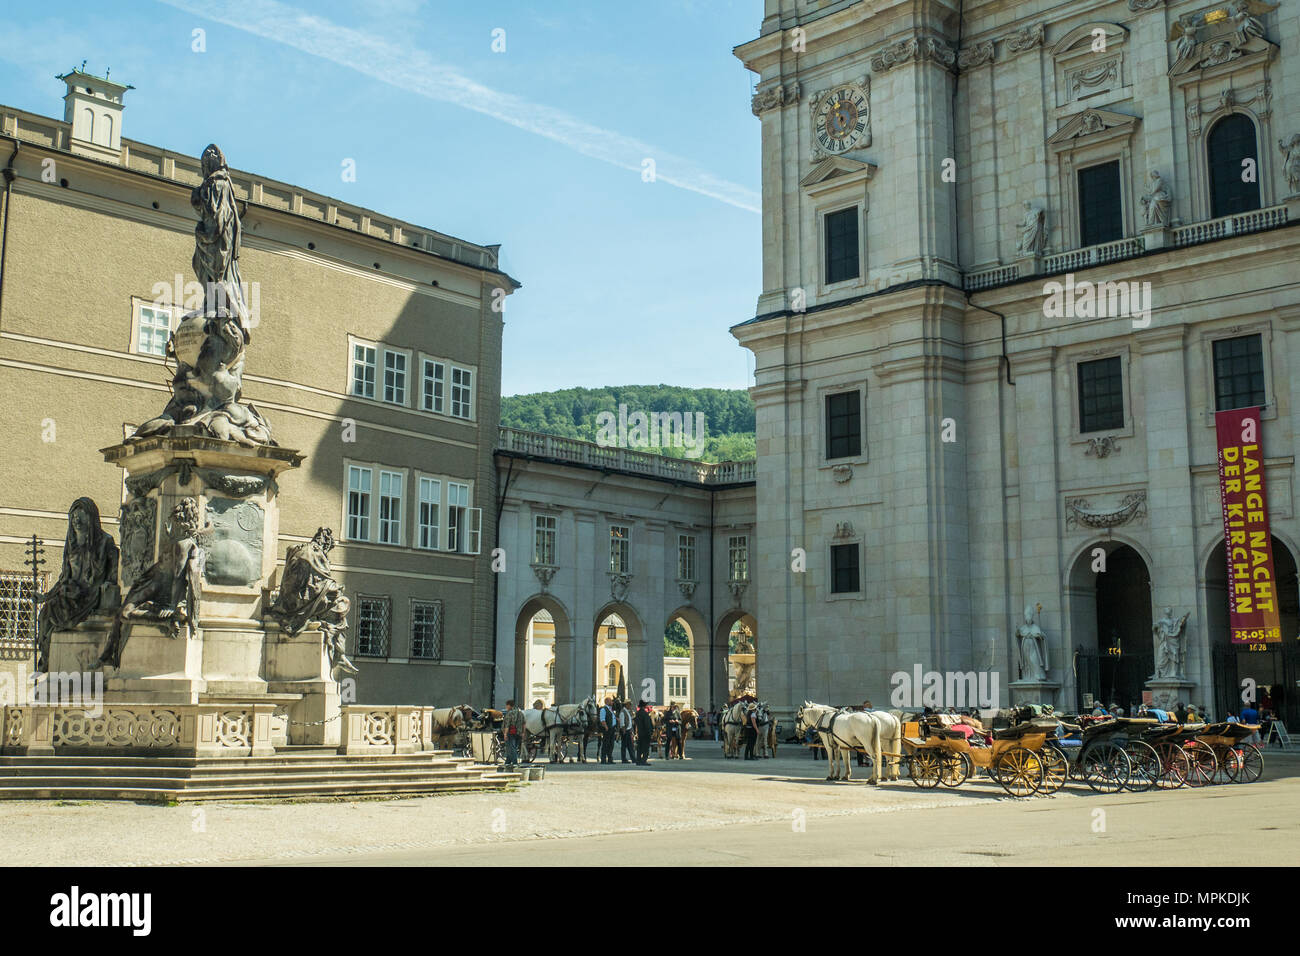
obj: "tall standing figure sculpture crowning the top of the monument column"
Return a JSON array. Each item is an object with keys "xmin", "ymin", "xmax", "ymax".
[{"xmin": 131, "ymin": 143, "xmax": 274, "ymax": 446}]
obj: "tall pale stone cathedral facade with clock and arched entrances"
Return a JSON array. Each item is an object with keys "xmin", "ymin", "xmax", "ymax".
[{"xmin": 733, "ymin": 0, "xmax": 1300, "ymax": 726}]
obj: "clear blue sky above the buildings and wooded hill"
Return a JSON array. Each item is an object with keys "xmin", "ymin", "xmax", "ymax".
[{"xmin": 0, "ymin": 0, "xmax": 762, "ymax": 394}]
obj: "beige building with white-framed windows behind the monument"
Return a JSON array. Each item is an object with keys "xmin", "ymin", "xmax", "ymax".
[{"xmin": 0, "ymin": 70, "xmax": 517, "ymax": 704}]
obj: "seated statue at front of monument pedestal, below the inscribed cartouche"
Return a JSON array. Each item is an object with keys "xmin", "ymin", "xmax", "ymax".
[{"xmin": 99, "ymin": 498, "xmax": 212, "ymax": 667}]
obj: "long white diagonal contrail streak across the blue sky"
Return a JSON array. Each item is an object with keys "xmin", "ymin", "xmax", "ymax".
[{"xmin": 159, "ymin": 0, "xmax": 761, "ymax": 212}]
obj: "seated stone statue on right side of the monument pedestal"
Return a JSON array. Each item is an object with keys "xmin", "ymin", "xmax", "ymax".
[{"xmin": 267, "ymin": 528, "xmax": 358, "ymax": 674}]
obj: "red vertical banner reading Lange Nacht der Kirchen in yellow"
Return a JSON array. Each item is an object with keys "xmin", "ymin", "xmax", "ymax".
[{"xmin": 1214, "ymin": 408, "xmax": 1282, "ymax": 644}]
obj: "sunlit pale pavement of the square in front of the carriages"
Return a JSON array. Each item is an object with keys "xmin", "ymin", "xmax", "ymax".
[{"xmin": 0, "ymin": 741, "xmax": 1300, "ymax": 865}]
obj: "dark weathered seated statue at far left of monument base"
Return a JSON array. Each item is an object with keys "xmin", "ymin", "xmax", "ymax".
[{"xmin": 36, "ymin": 498, "xmax": 121, "ymax": 672}]
